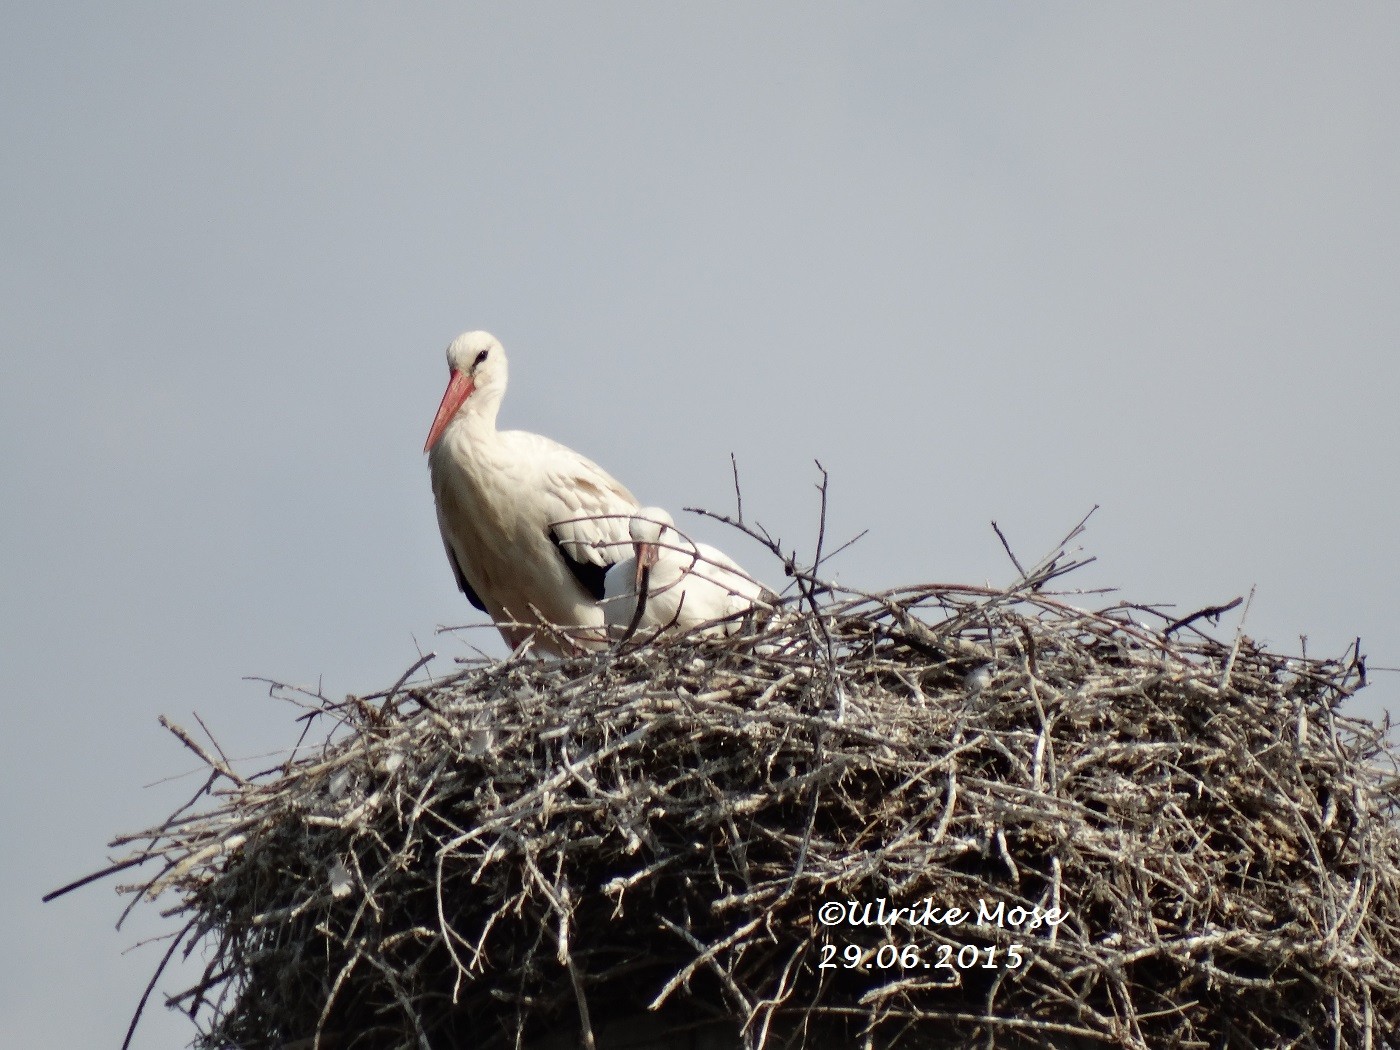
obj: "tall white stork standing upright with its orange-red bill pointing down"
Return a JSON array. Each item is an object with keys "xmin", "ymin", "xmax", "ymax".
[{"xmin": 423, "ymin": 332, "xmax": 637, "ymax": 655}]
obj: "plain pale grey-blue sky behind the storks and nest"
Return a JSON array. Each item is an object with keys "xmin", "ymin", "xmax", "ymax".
[{"xmin": 0, "ymin": 1, "xmax": 1400, "ymax": 1047}]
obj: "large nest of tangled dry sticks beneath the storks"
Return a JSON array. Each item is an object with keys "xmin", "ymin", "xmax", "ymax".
[{"xmin": 57, "ymin": 518, "xmax": 1400, "ymax": 1050}]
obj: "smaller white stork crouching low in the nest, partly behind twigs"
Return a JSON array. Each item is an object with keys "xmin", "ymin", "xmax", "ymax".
[{"xmin": 603, "ymin": 507, "xmax": 773, "ymax": 638}]
